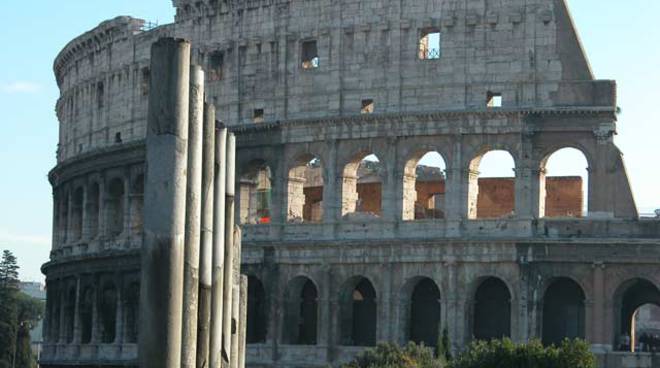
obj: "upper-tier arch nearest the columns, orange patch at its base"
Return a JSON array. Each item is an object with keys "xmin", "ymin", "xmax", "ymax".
[{"xmin": 239, "ymin": 160, "xmax": 272, "ymax": 224}]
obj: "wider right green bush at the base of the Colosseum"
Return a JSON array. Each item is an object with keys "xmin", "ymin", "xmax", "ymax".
[{"xmin": 450, "ymin": 339, "xmax": 596, "ymax": 368}]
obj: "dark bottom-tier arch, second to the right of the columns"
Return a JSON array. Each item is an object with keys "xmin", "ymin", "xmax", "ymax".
[{"xmin": 282, "ymin": 276, "xmax": 318, "ymax": 345}]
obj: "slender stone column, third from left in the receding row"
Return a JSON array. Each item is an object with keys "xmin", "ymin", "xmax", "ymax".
[{"xmin": 196, "ymin": 104, "xmax": 215, "ymax": 368}]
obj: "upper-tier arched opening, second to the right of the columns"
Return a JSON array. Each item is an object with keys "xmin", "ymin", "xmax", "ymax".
[{"xmin": 287, "ymin": 156, "xmax": 323, "ymax": 222}]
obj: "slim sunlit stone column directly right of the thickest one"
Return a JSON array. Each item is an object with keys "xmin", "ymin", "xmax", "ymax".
[{"xmin": 181, "ymin": 65, "xmax": 204, "ymax": 368}]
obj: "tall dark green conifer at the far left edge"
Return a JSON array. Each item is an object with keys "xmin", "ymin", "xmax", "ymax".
[{"xmin": 0, "ymin": 250, "xmax": 18, "ymax": 368}]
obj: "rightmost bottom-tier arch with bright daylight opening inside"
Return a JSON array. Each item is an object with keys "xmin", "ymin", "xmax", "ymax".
[{"xmin": 614, "ymin": 279, "xmax": 660, "ymax": 351}]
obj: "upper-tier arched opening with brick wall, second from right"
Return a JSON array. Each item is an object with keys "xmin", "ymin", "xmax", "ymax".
[{"xmin": 468, "ymin": 150, "xmax": 516, "ymax": 219}]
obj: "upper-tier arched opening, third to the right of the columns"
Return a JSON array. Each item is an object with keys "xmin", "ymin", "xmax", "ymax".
[{"xmin": 341, "ymin": 154, "xmax": 384, "ymax": 217}]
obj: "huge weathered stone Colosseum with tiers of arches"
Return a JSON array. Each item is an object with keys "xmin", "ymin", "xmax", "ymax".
[{"xmin": 41, "ymin": 0, "xmax": 660, "ymax": 368}]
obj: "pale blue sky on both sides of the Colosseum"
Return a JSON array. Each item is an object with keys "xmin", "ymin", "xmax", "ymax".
[{"xmin": 0, "ymin": 0, "xmax": 660, "ymax": 280}]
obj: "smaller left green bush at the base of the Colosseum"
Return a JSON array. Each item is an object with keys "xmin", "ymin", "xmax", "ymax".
[{"xmin": 343, "ymin": 342, "xmax": 445, "ymax": 368}]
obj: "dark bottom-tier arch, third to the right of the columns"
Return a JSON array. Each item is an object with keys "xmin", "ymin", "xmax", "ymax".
[{"xmin": 340, "ymin": 276, "xmax": 378, "ymax": 346}]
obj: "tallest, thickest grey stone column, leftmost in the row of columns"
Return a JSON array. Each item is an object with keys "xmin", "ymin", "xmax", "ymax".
[{"xmin": 139, "ymin": 38, "xmax": 190, "ymax": 368}]
